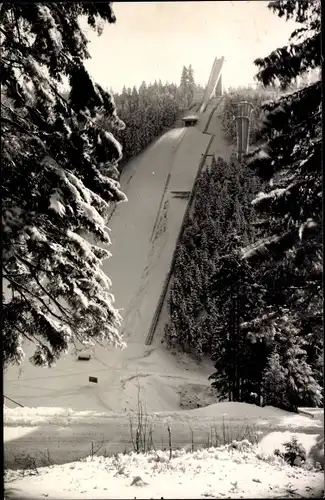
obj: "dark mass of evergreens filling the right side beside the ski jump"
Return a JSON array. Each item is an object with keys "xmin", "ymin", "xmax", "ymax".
[{"xmin": 166, "ymin": 0, "xmax": 323, "ymax": 411}]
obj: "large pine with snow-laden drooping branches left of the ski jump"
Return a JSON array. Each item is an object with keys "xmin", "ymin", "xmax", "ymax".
[{"xmin": 0, "ymin": 2, "xmax": 125, "ymax": 366}]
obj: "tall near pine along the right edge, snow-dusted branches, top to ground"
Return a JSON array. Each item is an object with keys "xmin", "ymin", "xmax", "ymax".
[{"xmin": 239, "ymin": 0, "xmax": 323, "ymax": 407}]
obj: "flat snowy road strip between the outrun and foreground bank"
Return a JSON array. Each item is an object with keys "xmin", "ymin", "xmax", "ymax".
[{"xmin": 4, "ymin": 402, "xmax": 324, "ymax": 468}]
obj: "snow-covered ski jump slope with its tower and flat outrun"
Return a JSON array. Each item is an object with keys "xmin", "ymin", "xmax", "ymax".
[{"xmin": 4, "ymin": 59, "xmax": 227, "ymax": 411}]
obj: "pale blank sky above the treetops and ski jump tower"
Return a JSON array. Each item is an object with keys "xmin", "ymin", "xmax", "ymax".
[{"xmin": 82, "ymin": 0, "xmax": 296, "ymax": 91}]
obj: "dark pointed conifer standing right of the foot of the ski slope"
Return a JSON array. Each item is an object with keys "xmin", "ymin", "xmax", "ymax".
[{"xmin": 208, "ymin": 250, "xmax": 269, "ymax": 402}]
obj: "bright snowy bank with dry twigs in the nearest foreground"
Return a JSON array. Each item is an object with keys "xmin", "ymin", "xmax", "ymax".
[{"xmin": 5, "ymin": 441, "xmax": 324, "ymax": 500}]
